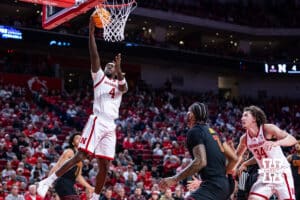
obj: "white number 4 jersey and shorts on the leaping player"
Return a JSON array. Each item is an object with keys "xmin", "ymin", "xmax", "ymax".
[{"xmin": 79, "ymin": 68, "xmax": 127, "ymax": 160}]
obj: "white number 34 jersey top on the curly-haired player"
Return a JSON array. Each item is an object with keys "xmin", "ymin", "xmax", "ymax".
[{"xmin": 246, "ymin": 126, "xmax": 290, "ymax": 168}]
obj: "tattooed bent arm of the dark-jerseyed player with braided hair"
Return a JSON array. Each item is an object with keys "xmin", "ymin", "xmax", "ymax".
[{"xmin": 159, "ymin": 144, "xmax": 207, "ymax": 189}]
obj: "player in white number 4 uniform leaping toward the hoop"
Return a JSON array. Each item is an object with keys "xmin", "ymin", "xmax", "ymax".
[{"xmin": 37, "ymin": 16, "xmax": 128, "ymax": 200}]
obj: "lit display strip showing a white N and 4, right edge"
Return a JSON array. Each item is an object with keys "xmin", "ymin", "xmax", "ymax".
[{"xmin": 265, "ymin": 63, "xmax": 300, "ymax": 74}]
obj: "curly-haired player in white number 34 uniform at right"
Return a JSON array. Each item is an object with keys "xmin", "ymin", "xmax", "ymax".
[{"xmin": 237, "ymin": 106, "xmax": 297, "ymax": 200}]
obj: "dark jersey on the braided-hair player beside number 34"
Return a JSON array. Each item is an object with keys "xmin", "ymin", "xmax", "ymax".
[{"xmin": 186, "ymin": 124, "xmax": 226, "ymax": 181}]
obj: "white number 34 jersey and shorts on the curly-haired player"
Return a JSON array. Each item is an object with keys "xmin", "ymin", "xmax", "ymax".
[{"xmin": 246, "ymin": 126, "xmax": 295, "ymax": 200}]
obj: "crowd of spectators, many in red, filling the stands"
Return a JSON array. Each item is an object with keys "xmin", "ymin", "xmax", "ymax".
[{"xmin": 0, "ymin": 77, "xmax": 300, "ymax": 200}]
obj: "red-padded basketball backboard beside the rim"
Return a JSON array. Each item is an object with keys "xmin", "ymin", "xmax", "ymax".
[{"xmin": 42, "ymin": 0, "xmax": 104, "ymax": 30}]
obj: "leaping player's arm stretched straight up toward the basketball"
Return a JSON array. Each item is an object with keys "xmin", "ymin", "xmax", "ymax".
[{"xmin": 89, "ymin": 16, "xmax": 101, "ymax": 73}]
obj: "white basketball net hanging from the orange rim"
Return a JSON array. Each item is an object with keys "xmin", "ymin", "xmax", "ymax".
[{"xmin": 96, "ymin": 0, "xmax": 137, "ymax": 42}]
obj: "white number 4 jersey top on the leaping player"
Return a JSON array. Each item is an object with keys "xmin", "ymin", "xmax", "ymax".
[{"xmin": 92, "ymin": 68, "xmax": 127, "ymax": 121}]
